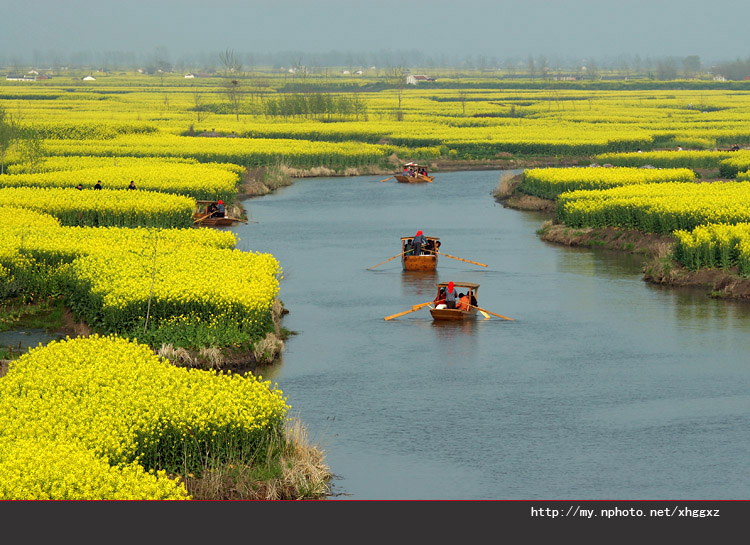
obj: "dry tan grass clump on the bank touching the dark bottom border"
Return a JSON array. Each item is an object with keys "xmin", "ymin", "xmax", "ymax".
[{"xmin": 183, "ymin": 418, "xmax": 333, "ymax": 500}]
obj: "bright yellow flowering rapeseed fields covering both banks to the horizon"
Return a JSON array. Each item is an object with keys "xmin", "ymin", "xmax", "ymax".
[{"xmin": 0, "ymin": 70, "xmax": 750, "ymax": 499}]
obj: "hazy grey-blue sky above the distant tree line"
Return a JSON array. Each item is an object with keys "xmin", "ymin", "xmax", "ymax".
[{"xmin": 0, "ymin": 0, "xmax": 750, "ymax": 63}]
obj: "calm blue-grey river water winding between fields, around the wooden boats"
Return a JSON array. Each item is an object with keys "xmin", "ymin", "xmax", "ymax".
[{"xmin": 232, "ymin": 171, "xmax": 750, "ymax": 500}]
